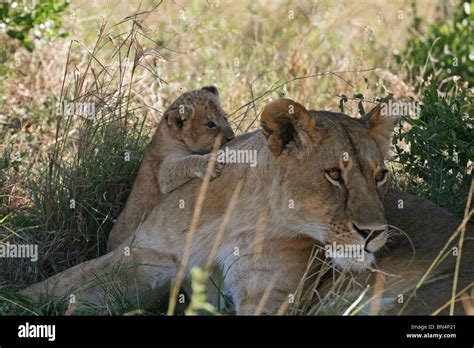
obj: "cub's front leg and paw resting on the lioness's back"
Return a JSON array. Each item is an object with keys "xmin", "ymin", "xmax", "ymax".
[{"xmin": 155, "ymin": 154, "xmax": 224, "ymax": 194}]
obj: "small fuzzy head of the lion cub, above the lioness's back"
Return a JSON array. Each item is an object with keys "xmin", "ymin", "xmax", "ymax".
[{"xmin": 163, "ymin": 86, "xmax": 234, "ymax": 154}]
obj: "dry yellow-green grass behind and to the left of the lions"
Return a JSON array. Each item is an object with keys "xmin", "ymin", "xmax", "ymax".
[{"xmin": 0, "ymin": 0, "xmax": 470, "ymax": 314}]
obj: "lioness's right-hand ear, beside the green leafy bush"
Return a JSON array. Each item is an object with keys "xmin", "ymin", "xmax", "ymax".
[{"xmin": 361, "ymin": 99, "xmax": 399, "ymax": 158}]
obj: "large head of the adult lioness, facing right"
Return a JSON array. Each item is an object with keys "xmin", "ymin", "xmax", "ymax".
[{"xmin": 261, "ymin": 99, "xmax": 396, "ymax": 270}]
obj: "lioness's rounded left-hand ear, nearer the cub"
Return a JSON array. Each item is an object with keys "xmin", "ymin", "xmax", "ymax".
[{"xmin": 260, "ymin": 99, "xmax": 317, "ymax": 157}]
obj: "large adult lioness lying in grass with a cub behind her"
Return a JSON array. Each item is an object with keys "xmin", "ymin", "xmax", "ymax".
[{"xmin": 23, "ymin": 99, "xmax": 400, "ymax": 314}]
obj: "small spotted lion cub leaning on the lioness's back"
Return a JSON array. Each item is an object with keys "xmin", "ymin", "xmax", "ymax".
[{"xmin": 107, "ymin": 86, "xmax": 234, "ymax": 251}]
